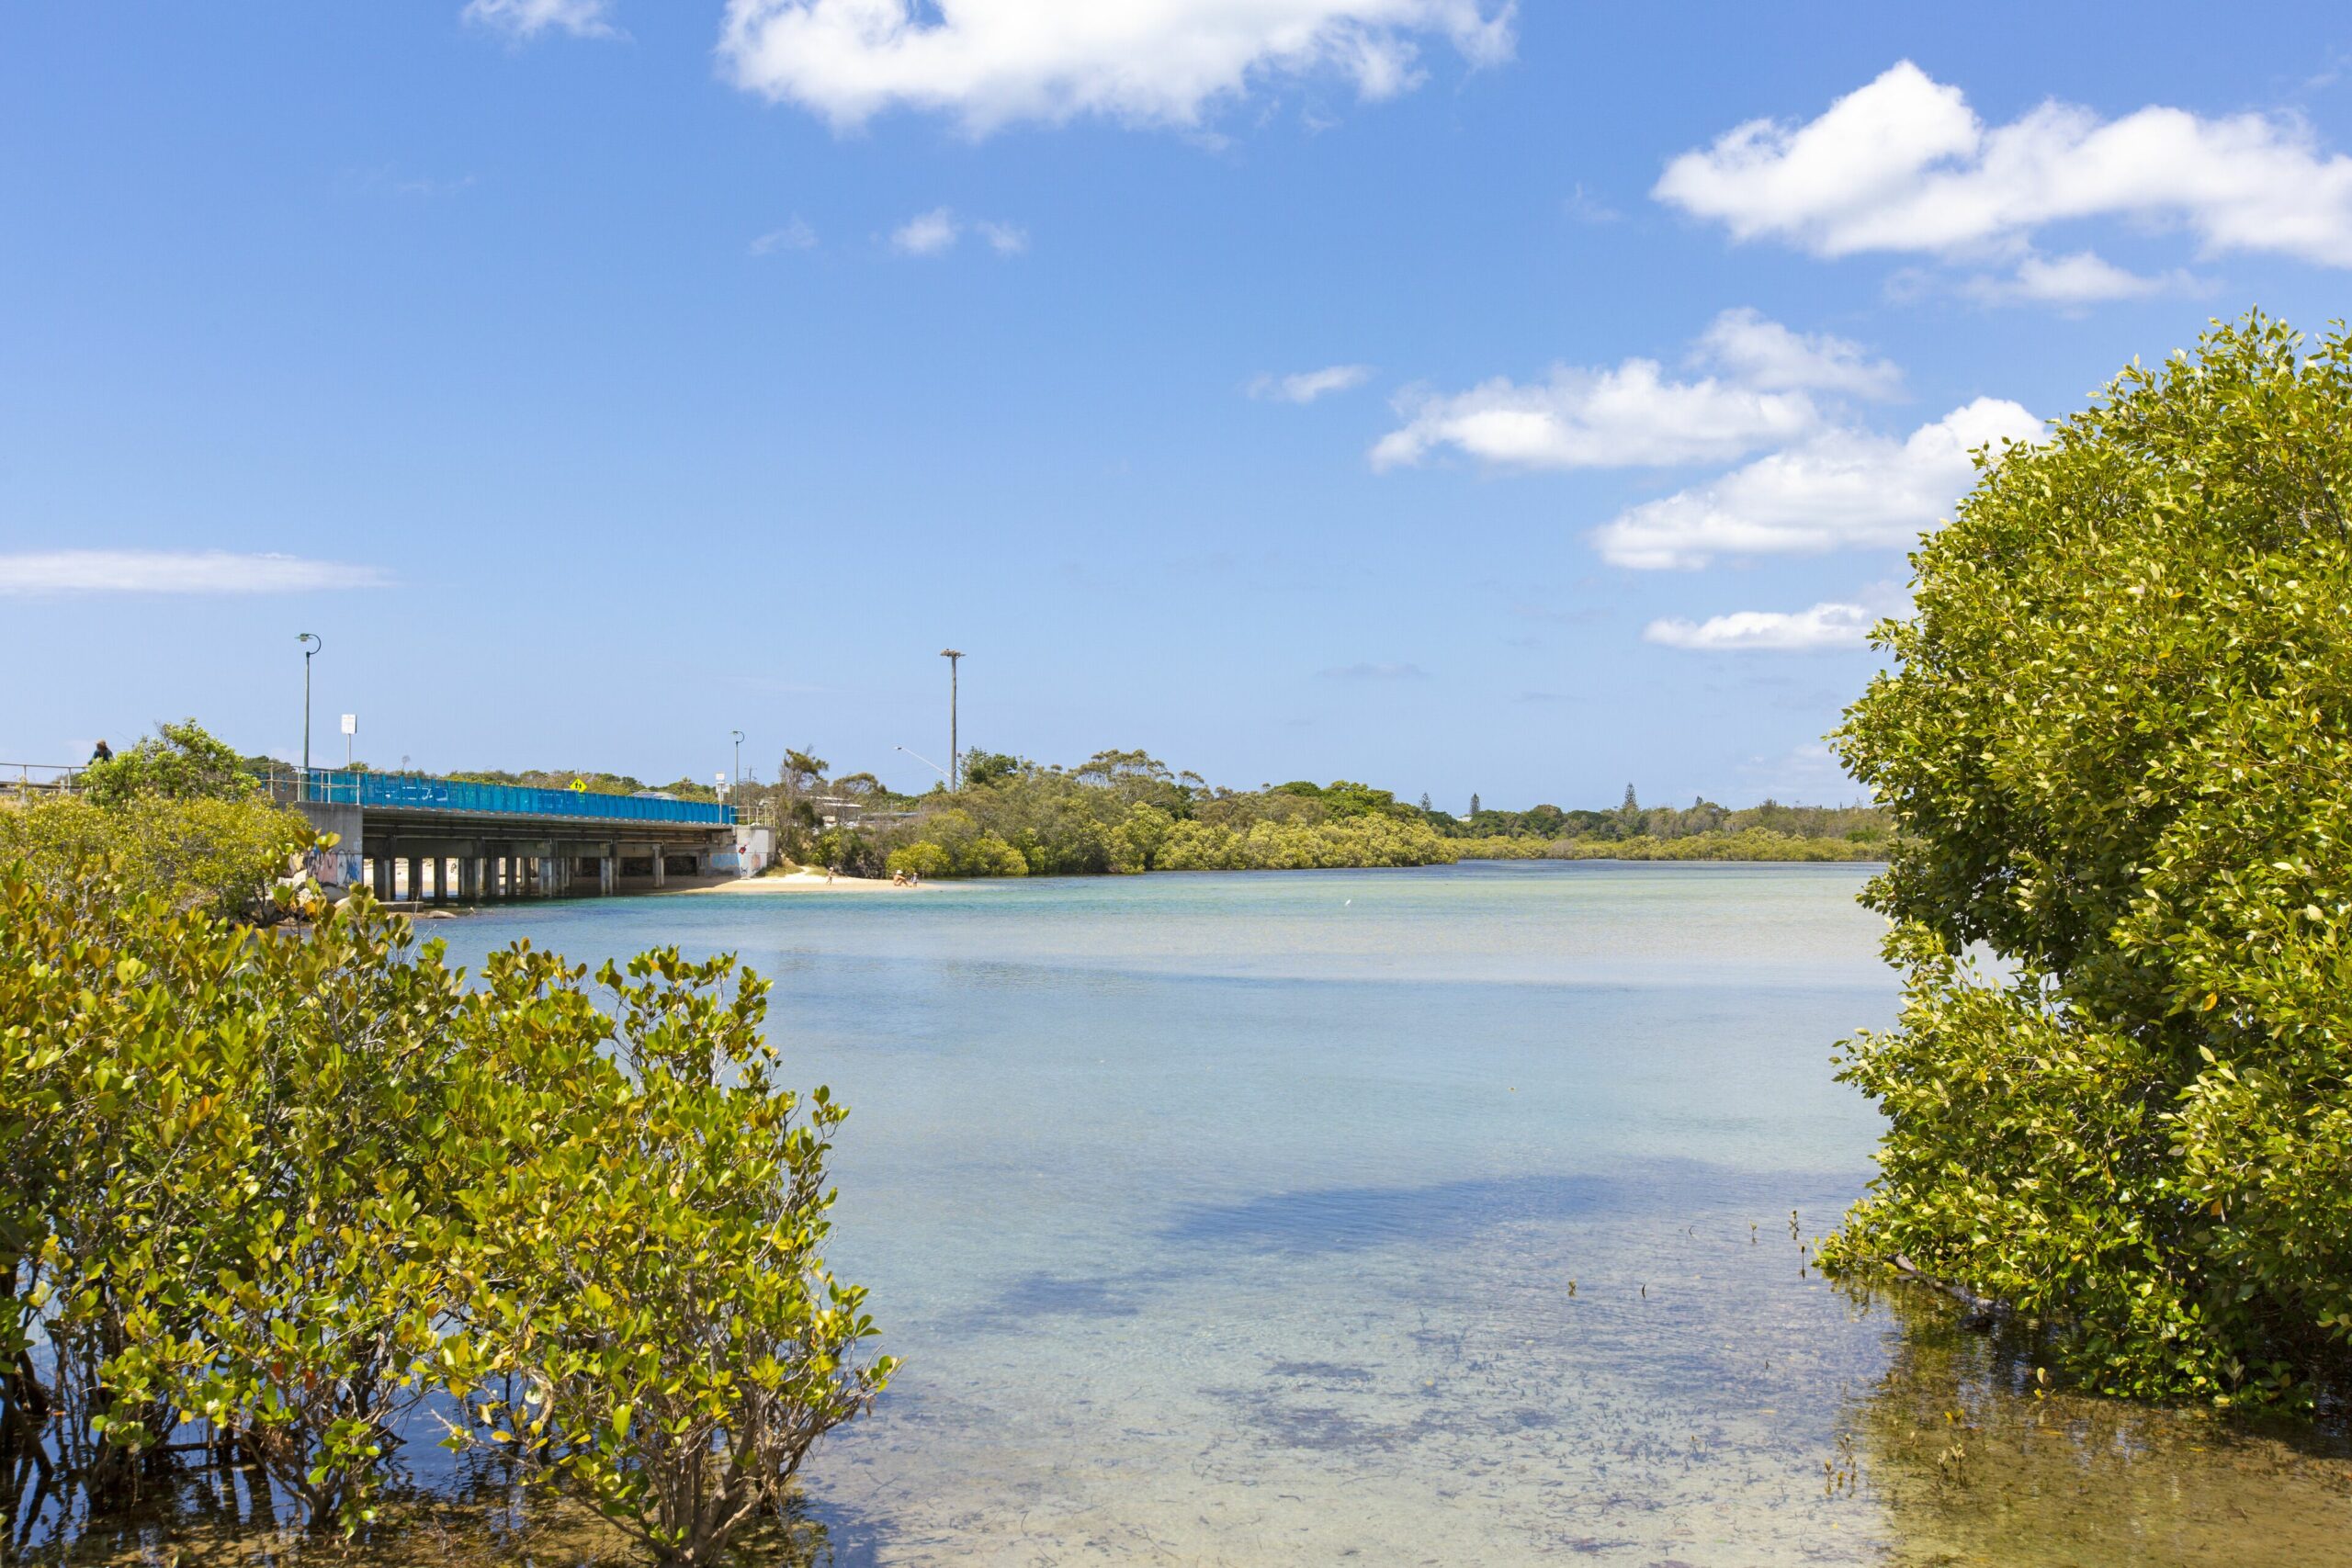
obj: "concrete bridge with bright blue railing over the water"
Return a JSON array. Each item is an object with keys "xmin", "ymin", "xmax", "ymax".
[{"xmin": 288, "ymin": 769, "xmax": 767, "ymax": 903}]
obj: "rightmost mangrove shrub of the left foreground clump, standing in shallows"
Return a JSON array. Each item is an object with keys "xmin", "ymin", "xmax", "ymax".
[{"xmin": 445, "ymin": 950, "xmax": 894, "ymax": 1565}]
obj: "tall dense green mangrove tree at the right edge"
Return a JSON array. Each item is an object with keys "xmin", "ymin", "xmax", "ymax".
[{"xmin": 1826, "ymin": 317, "xmax": 2352, "ymax": 1405}]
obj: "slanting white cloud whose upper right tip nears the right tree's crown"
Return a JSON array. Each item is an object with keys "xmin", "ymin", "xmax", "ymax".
[{"xmin": 1592, "ymin": 398, "xmax": 2041, "ymax": 567}]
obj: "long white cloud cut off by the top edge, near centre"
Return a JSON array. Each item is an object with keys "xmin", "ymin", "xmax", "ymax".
[{"xmin": 715, "ymin": 0, "xmax": 1515, "ymax": 131}]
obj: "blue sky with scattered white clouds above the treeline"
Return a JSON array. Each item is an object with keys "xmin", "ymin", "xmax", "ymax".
[{"xmin": 0, "ymin": 0, "xmax": 2352, "ymax": 808}]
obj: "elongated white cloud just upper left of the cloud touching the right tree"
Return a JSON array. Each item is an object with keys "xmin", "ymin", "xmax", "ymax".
[{"xmin": 1371, "ymin": 360, "xmax": 1815, "ymax": 468}]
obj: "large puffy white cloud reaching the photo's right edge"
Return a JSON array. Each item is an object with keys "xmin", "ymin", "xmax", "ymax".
[{"xmin": 1651, "ymin": 62, "xmax": 2352, "ymax": 265}]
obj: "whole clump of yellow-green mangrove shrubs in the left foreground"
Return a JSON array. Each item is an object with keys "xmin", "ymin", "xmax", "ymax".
[{"xmin": 0, "ymin": 863, "xmax": 889, "ymax": 1563}]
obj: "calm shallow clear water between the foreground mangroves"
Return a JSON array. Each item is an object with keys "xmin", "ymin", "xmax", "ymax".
[{"xmin": 428, "ymin": 865, "xmax": 2352, "ymax": 1565}]
